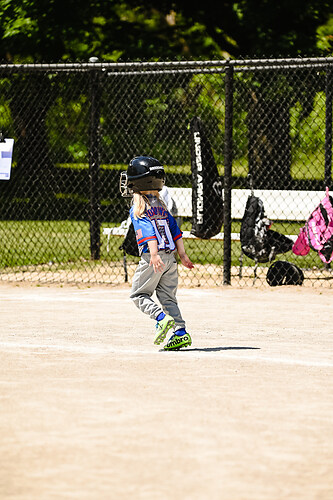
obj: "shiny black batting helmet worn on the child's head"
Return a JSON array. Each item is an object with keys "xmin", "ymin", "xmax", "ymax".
[{"xmin": 120, "ymin": 156, "xmax": 165, "ymax": 196}]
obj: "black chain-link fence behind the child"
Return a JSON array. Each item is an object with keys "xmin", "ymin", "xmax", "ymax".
[{"xmin": 0, "ymin": 58, "xmax": 333, "ymax": 286}]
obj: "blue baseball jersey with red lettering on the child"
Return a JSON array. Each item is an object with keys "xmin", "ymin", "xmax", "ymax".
[{"xmin": 130, "ymin": 195, "xmax": 182, "ymax": 255}]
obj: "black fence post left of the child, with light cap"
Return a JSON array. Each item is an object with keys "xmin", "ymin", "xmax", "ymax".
[{"xmin": 89, "ymin": 60, "xmax": 101, "ymax": 260}]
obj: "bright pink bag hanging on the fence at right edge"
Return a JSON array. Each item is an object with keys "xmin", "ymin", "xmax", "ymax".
[{"xmin": 292, "ymin": 187, "xmax": 333, "ymax": 264}]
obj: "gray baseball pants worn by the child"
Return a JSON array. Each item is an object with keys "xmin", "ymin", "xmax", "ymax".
[{"xmin": 130, "ymin": 250, "xmax": 185, "ymax": 330}]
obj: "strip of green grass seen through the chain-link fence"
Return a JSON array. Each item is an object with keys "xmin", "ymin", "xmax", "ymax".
[{"xmin": 0, "ymin": 221, "xmax": 323, "ymax": 269}]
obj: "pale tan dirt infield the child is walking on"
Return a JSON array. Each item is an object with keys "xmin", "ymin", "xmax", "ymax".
[{"xmin": 0, "ymin": 284, "xmax": 333, "ymax": 500}]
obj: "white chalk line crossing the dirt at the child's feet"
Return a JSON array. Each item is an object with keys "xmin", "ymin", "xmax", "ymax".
[{"xmin": 0, "ymin": 342, "xmax": 333, "ymax": 368}]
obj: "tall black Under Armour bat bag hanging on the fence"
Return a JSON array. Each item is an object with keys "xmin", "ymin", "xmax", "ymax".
[{"xmin": 190, "ymin": 116, "xmax": 223, "ymax": 239}]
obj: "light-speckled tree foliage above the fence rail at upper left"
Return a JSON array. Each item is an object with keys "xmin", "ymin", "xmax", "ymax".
[{"xmin": 0, "ymin": 0, "xmax": 222, "ymax": 63}]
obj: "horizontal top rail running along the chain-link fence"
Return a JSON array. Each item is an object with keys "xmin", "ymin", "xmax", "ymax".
[{"xmin": 0, "ymin": 57, "xmax": 333, "ymax": 72}]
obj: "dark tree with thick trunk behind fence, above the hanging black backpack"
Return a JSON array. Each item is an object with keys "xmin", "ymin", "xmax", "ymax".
[{"xmin": 159, "ymin": 0, "xmax": 333, "ymax": 188}]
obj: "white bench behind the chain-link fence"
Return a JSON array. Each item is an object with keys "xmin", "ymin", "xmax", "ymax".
[{"xmin": 103, "ymin": 187, "xmax": 325, "ymax": 251}]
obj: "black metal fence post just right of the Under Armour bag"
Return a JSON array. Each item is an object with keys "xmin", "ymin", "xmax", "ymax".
[{"xmin": 223, "ymin": 63, "xmax": 234, "ymax": 285}]
